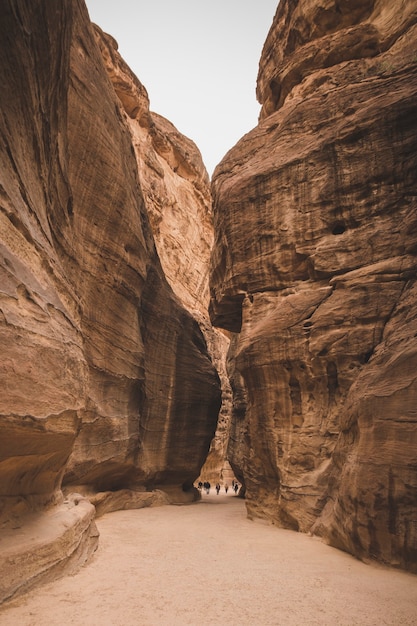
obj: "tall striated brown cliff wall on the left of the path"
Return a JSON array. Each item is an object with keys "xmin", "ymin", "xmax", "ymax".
[{"xmin": 0, "ymin": 0, "xmax": 220, "ymax": 599}]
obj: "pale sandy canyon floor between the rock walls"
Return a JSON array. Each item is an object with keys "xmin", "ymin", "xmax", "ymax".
[{"xmin": 0, "ymin": 492, "xmax": 417, "ymax": 626}]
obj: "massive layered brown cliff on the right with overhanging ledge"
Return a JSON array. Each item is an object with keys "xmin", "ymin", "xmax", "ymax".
[{"xmin": 210, "ymin": 0, "xmax": 417, "ymax": 571}]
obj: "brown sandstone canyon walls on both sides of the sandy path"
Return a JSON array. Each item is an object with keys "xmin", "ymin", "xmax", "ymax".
[{"xmin": 0, "ymin": 0, "xmax": 417, "ymax": 602}]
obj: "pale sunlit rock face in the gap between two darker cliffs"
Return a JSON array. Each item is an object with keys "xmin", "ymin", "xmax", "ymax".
[{"xmin": 95, "ymin": 26, "xmax": 231, "ymax": 476}]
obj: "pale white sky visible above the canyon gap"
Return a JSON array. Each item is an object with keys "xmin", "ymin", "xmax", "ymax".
[{"xmin": 86, "ymin": 0, "xmax": 278, "ymax": 176}]
